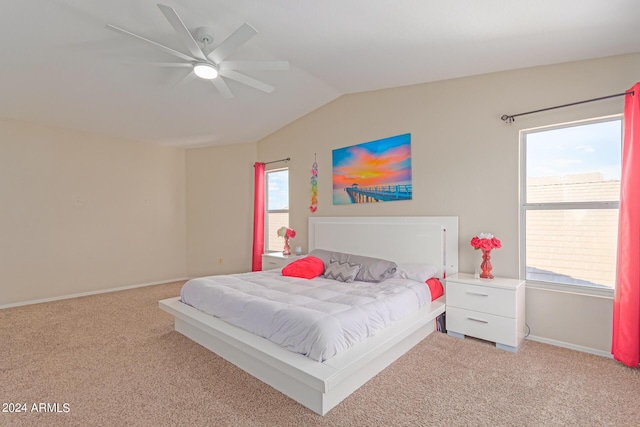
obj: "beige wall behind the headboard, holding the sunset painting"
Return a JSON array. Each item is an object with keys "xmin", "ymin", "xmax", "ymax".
[{"xmin": 251, "ymin": 54, "xmax": 640, "ymax": 353}]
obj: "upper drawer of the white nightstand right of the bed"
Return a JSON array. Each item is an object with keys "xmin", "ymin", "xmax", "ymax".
[{"xmin": 447, "ymin": 281, "xmax": 516, "ymax": 318}]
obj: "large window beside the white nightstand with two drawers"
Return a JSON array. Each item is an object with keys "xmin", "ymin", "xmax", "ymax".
[{"xmin": 520, "ymin": 116, "xmax": 622, "ymax": 294}]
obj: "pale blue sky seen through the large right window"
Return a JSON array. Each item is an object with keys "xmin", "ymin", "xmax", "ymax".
[{"xmin": 527, "ymin": 119, "xmax": 622, "ymax": 180}]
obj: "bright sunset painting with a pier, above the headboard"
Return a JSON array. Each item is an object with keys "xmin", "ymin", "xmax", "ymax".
[{"xmin": 332, "ymin": 133, "xmax": 413, "ymax": 205}]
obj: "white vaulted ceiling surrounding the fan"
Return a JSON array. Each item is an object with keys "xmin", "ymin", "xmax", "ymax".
[{"xmin": 0, "ymin": 0, "xmax": 640, "ymax": 147}]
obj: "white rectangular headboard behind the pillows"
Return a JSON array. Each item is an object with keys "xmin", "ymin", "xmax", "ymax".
[{"xmin": 309, "ymin": 216, "xmax": 458, "ymax": 278}]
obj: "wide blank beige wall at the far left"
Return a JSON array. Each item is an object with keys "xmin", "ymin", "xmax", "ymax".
[{"xmin": 0, "ymin": 120, "xmax": 186, "ymax": 306}]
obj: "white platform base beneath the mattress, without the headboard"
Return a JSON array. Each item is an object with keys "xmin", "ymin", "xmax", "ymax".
[{"xmin": 160, "ymin": 297, "xmax": 445, "ymax": 415}]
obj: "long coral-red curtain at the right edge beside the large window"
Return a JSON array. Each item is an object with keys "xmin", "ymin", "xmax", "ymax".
[{"xmin": 611, "ymin": 83, "xmax": 640, "ymax": 367}]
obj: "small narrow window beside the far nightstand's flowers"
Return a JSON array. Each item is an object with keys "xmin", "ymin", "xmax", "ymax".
[{"xmin": 264, "ymin": 169, "xmax": 289, "ymax": 252}]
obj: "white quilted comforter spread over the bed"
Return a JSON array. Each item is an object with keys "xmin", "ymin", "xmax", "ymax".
[{"xmin": 181, "ymin": 270, "xmax": 431, "ymax": 361}]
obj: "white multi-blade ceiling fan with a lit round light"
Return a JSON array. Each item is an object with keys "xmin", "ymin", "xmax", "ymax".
[{"xmin": 107, "ymin": 4, "xmax": 289, "ymax": 99}]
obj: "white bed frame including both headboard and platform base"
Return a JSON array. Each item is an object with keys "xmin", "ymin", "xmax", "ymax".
[{"xmin": 159, "ymin": 216, "xmax": 458, "ymax": 415}]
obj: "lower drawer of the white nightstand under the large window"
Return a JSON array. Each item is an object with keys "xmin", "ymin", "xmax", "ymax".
[{"xmin": 447, "ymin": 306, "xmax": 519, "ymax": 347}]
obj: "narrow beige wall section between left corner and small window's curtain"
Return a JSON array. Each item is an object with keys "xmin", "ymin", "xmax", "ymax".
[{"xmin": 186, "ymin": 143, "xmax": 257, "ymax": 277}]
